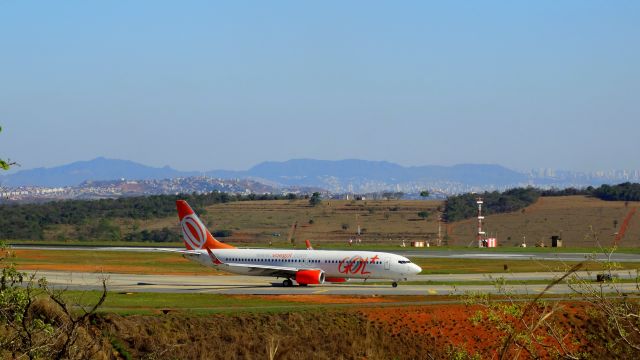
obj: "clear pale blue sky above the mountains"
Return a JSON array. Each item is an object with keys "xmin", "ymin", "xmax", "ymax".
[{"xmin": 0, "ymin": 0, "xmax": 640, "ymax": 170}]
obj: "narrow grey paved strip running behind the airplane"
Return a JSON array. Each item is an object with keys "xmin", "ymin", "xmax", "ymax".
[{"xmin": 11, "ymin": 245, "xmax": 640, "ymax": 262}]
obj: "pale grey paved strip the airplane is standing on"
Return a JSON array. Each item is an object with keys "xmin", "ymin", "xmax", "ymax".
[{"xmin": 27, "ymin": 271, "xmax": 638, "ymax": 295}]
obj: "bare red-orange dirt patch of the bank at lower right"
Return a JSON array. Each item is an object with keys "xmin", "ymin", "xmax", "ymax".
[{"xmin": 360, "ymin": 302, "xmax": 638, "ymax": 359}]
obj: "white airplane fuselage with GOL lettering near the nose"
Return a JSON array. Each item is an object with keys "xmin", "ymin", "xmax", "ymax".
[{"xmin": 185, "ymin": 249, "xmax": 422, "ymax": 281}]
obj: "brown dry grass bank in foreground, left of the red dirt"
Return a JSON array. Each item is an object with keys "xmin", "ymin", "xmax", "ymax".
[{"xmin": 99, "ymin": 311, "xmax": 444, "ymax": 359}]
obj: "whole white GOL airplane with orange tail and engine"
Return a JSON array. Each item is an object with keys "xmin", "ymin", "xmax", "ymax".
[{"xmin": 176, "ymin": 200, "xmax": 422, "ymax": 287}]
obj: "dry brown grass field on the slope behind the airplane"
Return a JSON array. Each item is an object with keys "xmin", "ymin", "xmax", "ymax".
[{"xmin": 31, "ymin": 196, "xmax": 640, "ymax": 250}]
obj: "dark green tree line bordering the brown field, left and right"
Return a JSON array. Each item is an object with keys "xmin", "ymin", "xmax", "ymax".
[{"xmin": 0, "ymin": 182, "xmax": 640, "ymax": 242}]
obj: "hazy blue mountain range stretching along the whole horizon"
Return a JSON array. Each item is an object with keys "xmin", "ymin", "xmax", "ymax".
[{"xmin": 0, "ymin": 157, "xmax": 640, "ymax": 193}]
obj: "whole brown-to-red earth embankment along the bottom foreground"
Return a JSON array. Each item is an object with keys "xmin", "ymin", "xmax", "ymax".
[{"xmin": 87, "ymin": 303, "xmax": 633, "ymax": 359}]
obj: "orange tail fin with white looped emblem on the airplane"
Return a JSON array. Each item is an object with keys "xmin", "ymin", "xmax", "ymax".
[{"xmin": 176, "ymin": 200, "xmax": 235, "ymax": 250}]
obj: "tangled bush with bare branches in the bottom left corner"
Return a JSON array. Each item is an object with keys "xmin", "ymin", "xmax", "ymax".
[{"xmin": 0, "ymin": 242, "xmax": 108, "ymax": 359}]
